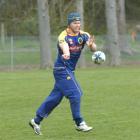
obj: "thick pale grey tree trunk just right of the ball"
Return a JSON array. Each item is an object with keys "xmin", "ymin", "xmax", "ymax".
[{"xmin": 105, "ymin": 0, "xmax": 120, "ymax": 66}]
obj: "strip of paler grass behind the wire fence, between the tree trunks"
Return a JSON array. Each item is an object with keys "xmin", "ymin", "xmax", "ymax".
[{"xmin": 0, "ymin": 36, "xmax": 140, "ymax": 67}]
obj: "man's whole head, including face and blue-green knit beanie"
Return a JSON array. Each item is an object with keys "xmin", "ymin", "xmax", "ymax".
[{"xmin": 67, "ymin": 12, "xmax": 81, "ymax": 34}]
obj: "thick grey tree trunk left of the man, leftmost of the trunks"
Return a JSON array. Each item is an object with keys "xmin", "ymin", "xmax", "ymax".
[{"xmin": 38, "ymin": 0, "xmax": 52, "ymax": 69}]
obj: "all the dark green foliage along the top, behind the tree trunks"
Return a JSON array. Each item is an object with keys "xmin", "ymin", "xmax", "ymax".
[{"xmin": 0, "ymin": 0, "xmax": 140, "ymax": 35}]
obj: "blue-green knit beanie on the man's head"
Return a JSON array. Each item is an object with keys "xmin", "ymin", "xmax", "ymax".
[{"xmin": 67, "ymin": 12, "xmax": 81, "ymax": 25}]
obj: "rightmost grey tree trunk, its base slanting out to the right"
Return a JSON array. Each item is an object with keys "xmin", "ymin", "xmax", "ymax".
[{"xmin": 117, "ymin": 0, "xmax": 132, "ymax": 54}]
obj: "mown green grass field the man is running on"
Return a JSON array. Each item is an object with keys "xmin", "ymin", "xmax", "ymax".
[{"xmin": 0, "ymin": 67, "xmax": 140, "ymax": 140}]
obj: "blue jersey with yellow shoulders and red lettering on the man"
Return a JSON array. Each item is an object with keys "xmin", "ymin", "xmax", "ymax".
[{"xmin": 54, "ymin": 28, "xmax": 90, "ymax": 71}]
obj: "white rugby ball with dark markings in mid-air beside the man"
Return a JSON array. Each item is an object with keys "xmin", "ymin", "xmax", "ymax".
[{"xmin": 92, "ymin": 51, "xmax": 106, "ymax": 64}]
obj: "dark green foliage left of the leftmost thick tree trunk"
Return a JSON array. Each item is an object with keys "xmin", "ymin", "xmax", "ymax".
[{"xmin": 0, "ymin": 0, "xmax": 38, "ymax": 35}]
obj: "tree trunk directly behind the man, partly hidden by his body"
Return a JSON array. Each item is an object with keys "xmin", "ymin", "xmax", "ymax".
[{"xmin": 76, "ymin": 0, "xmax": 86, "ymax": 68}]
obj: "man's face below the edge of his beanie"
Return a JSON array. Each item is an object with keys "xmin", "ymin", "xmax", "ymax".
[{"xmin": 69, "ymin": 21, "xmax": 81, "ymax": 33}]
